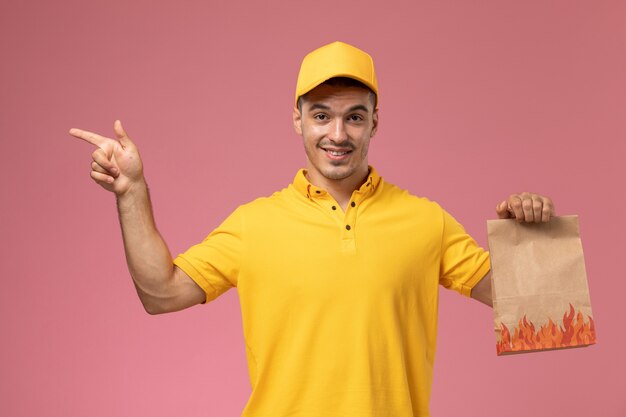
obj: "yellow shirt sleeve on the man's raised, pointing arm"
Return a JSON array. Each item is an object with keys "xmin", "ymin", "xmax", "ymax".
[{"xmin": 174, "ymin": 208, "xmax": 243, "ymax": 302}]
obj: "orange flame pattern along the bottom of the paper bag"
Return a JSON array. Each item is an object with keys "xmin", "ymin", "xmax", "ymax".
[{"xmin": 496, "ymin": 304, "xmax": 596, "ymax": 355}]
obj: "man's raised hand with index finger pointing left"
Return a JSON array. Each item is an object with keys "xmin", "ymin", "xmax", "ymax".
[{"xmin": 69, "ymin": 120, "xmax": 143, "ymax": 196}]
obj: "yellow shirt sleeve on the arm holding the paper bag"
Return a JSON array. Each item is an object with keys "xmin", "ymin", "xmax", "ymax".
[{"xmin": 439, "ymin": 210, "xmax": 490, "ymax": 297}]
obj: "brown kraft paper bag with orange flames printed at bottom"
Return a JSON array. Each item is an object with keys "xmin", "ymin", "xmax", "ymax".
[{"xmin": 487, "ymin": 216, "xmax": 596, "ymax": 355}]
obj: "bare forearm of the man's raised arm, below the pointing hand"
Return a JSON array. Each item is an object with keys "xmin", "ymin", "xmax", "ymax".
[{"xmin": 117, "ymin": 181, "xmax": 174, "ymax": 309}]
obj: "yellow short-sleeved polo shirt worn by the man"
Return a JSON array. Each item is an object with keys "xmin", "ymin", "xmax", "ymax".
[{"xmin": 174, "ymin": 168, "xmax": 489, "ymax": 417}]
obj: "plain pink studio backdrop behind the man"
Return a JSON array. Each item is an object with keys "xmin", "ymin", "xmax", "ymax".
[{"xmin": 0, "ymin": 0, "xmax": 626, "ymax": 417}]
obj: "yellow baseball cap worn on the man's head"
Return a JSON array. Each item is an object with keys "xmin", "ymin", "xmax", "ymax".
[{"xmin": 296, "ymin": 42, "xmax": 378, "ymax": 106}]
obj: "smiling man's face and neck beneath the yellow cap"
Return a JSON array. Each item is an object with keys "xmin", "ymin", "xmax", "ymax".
[{"xmin": 293, "ymin": 84, "xmax": 378, "ymax": 182}]
